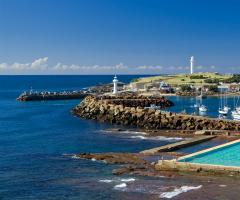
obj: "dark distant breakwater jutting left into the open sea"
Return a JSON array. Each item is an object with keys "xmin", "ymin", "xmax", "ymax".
[{"xmin": 16, "ymin": 92, "xmax": 91, "ymax": 101}]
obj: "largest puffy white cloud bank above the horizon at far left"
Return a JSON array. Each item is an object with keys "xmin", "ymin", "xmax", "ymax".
[{"xmin": 0, "ymin": 57, "xmax": 48, "ymax": 70}]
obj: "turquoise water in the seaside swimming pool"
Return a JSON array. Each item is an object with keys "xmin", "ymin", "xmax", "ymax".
[{"xmin": 179, "ymin": 142, "xmax": 240, "ymax": 167}]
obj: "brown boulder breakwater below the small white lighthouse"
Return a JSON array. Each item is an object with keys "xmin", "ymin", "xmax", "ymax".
[{"xmin": 71, "ymin": 94, "xmax": 240, "ymax": 131}]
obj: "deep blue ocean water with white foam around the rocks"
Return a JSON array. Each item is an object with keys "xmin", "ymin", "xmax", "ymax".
[{"xmin": 0, "ymin": 75, "xmax": 239, "ymax": 200}]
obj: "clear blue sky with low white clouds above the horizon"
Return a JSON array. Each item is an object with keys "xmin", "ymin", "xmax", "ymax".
[{"xmin": 0, "ymin": 0, "xmax": 240, "ymax": 75}]
